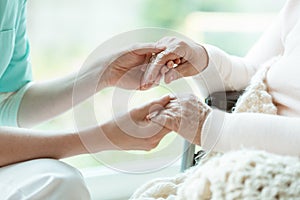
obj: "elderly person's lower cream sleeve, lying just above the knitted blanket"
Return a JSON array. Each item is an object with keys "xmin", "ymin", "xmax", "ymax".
[{"xmin": 201, "ymin": 109, "xmax": 300, "ymax": 156}]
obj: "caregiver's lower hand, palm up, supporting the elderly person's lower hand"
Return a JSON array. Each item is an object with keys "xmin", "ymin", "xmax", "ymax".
[{"xmin": 104, "ymin": 96, "xmax": 173, "ymax": 150}]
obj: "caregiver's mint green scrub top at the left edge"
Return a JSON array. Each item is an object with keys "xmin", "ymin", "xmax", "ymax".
[{"xmin": 0, "ymin": 0, "xmax": 32, "ymax": 126}]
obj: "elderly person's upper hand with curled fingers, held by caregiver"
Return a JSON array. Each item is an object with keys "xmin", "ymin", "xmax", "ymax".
[{"xmin": 142, "ymin": 37, "xmax": 208, "ymax": 89}]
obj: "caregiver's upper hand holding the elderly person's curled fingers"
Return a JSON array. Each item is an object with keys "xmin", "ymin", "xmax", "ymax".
[{"xmin": 103, "ymin": 43, "xmax": 165, "ymax": 90}]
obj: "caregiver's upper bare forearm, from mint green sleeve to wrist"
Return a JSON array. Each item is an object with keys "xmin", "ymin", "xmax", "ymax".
[{"xmin": 18, "ymin": 63, "xmax": 106, "ymax": 127}]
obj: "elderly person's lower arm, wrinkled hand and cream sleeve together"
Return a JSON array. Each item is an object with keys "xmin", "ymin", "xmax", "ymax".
[{"xmin": 148, "ymin": 95, "xmax": 300, "ymax": 156}]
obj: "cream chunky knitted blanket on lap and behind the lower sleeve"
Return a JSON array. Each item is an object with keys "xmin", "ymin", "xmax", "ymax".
[{"xmin": 131, "ymin": 59, "xmax": 300, "ymax": 200}]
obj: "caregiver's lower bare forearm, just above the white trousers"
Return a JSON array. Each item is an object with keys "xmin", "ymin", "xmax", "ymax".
[{"xmin": 0, "ymin": 127, "xmax": 86, "ymax": 166}]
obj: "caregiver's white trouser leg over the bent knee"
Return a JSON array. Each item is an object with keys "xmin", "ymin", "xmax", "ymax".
[{"xmin": 0, "ymin": 159, "xmax": 90, "ymax": 200}]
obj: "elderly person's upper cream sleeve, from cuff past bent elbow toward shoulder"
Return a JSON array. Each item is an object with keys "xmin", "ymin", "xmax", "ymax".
[{"xmin": 194, "ymin": 6, "xmax": 286, "ymax": 96}]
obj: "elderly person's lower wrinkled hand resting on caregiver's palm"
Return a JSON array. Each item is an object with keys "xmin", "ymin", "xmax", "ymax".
[{"xmin": 148, "ymin": 95, "xmax": 211, "ymax": 145}]
